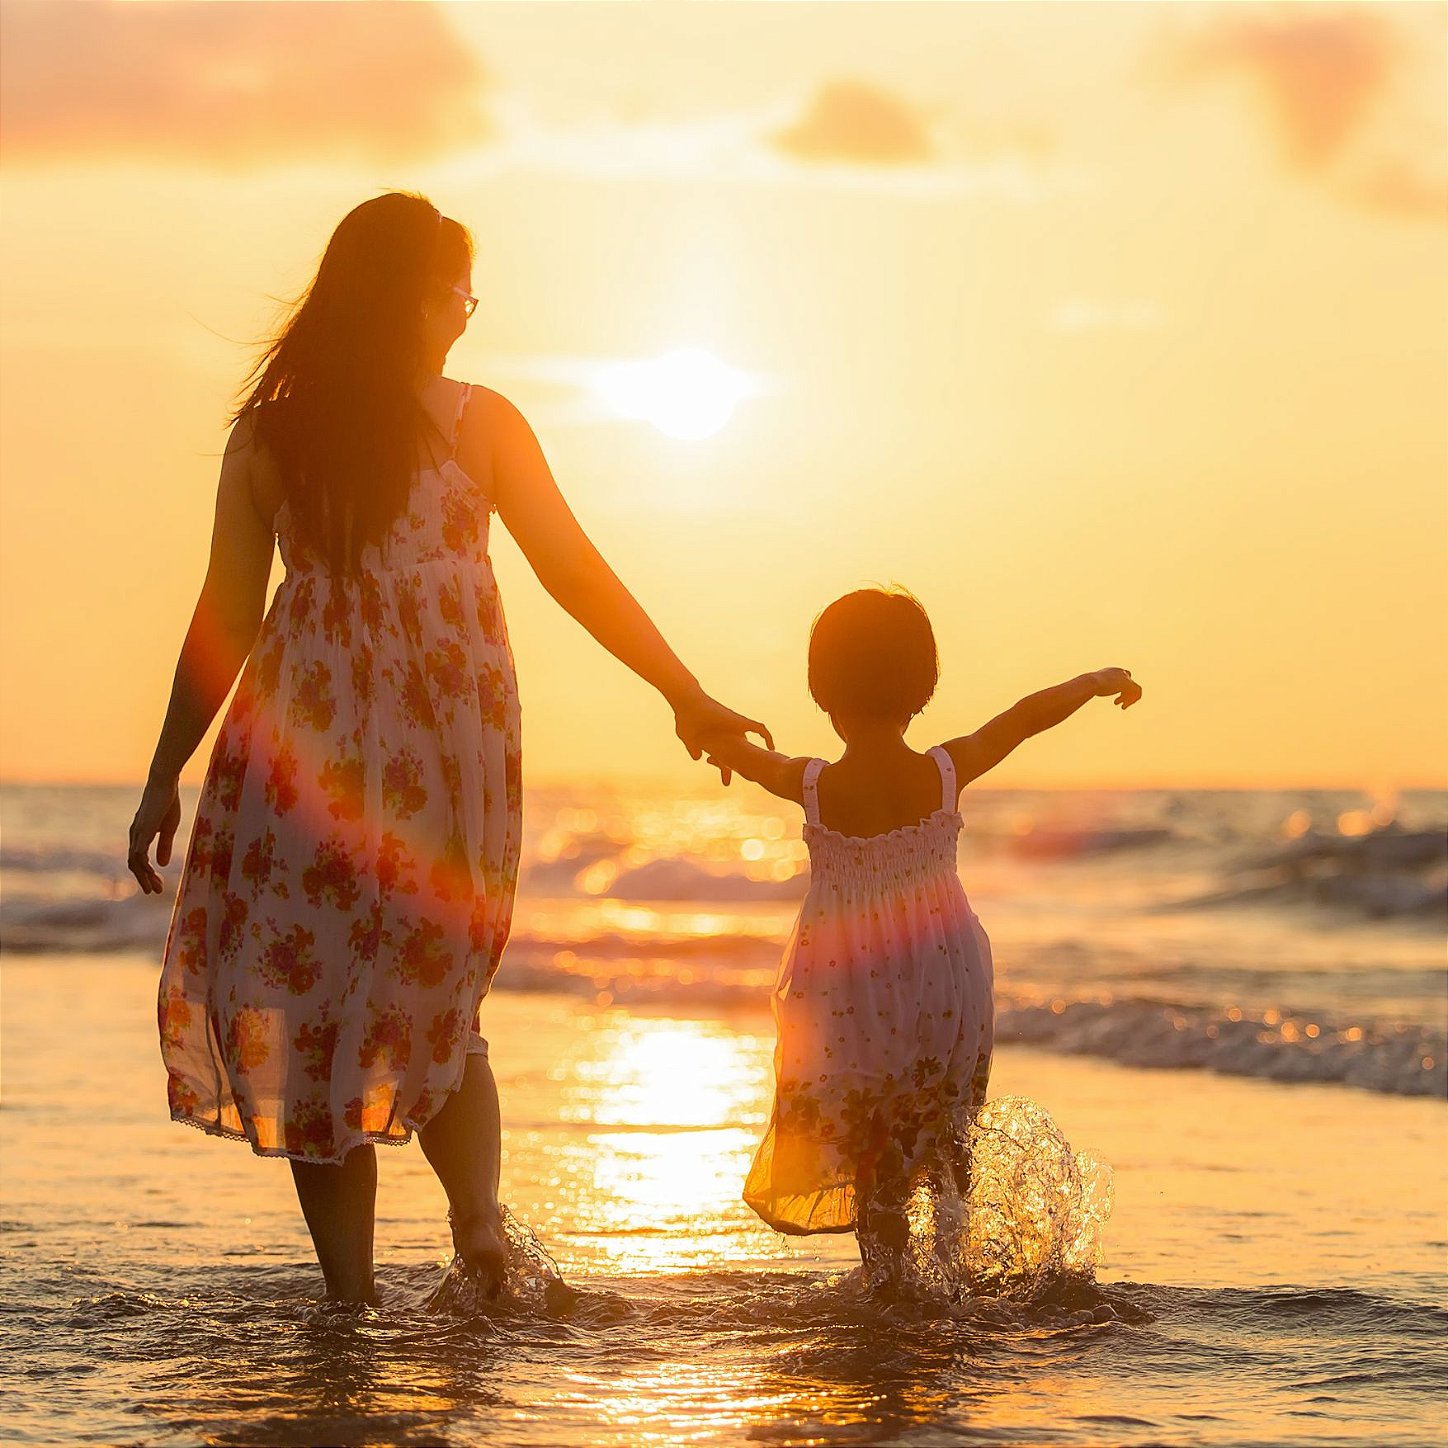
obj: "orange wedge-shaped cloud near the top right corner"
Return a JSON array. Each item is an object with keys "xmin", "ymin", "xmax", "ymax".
[{"xmin": 1146, "ymin": 7, "xmax": 1400, "ymax": 171}]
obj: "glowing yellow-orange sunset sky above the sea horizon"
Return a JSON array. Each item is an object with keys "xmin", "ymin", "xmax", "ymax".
[{"xmin": 0, "ymin": 0, "xmax": 1448, "ymax": 791}]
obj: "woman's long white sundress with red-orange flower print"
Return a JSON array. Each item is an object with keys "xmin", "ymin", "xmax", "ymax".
[{"xmin": 159, "ymin": 387, "xmax": 521, "ymax": 1161}]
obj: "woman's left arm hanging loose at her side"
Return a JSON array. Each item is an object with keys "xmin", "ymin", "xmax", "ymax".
[{"xmin": 126, "ymin": 418, "xmax": 274, "ymax": 895}]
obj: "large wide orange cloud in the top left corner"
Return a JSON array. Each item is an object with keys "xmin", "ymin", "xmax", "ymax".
[{"xmin": 0, "ymin": 0, "xmax": 489, "ymax": 168}]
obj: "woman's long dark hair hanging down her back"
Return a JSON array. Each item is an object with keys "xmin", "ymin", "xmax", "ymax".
[{"xmin": 233, "ymin": 191, "xmax": 472, "ymax": 573}]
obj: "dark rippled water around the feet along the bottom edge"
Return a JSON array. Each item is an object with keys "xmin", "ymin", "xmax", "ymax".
[{"xmin": 0, "ymin": 1256, "xmax": 1448, "ymax": 1448}]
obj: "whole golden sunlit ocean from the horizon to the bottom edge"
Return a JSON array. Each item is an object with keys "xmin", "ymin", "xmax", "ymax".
[{"xmin": 0, "ymin": 785, "xmax": 1448, "ymax": 1445}]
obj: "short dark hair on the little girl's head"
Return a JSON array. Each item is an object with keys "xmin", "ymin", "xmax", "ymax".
[{"xmin": 809, "ymin": 588, "xmax": 940, "ymax": 720}]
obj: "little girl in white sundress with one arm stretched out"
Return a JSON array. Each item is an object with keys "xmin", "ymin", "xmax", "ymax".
[{"xmin": 700, "ymin": 589, "xmax": 1141, "ymax": 1280}]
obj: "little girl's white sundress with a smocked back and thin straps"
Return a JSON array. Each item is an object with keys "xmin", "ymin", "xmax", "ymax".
[{"xmin": 744, "ymin": 746, "xmax": 995, "ymax": 1234}]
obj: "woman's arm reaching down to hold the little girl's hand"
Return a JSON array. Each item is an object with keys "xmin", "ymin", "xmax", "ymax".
[{"xmin": 483, "ymin": 388, "xmax": 772, "ymax": 780}]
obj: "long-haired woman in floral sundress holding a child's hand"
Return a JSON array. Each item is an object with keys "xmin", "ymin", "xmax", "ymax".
[{"xmin": 129, "ymin": 193, "xmax": 762, "ymax": 1303}]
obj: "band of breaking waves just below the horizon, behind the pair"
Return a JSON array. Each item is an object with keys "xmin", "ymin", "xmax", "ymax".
[{"xmin": 0, "ymin": 786, "xmax": 1448, "ymax": 1098}]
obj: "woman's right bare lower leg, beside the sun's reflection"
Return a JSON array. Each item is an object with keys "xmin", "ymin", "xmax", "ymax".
[{"xmin": 417, "ymin": 1056, "xmax": 507, "ymax": 1289}]
